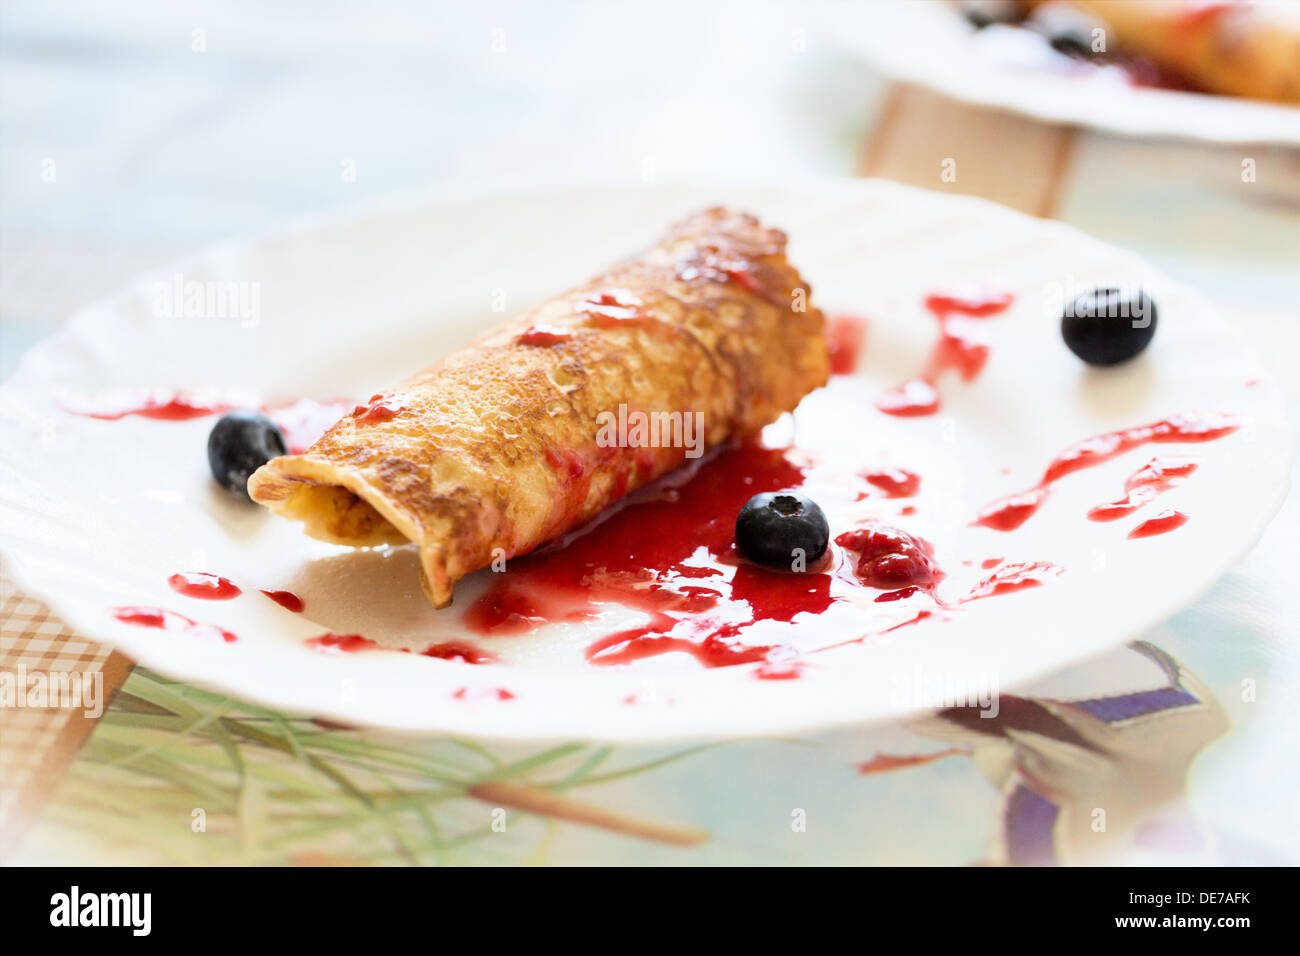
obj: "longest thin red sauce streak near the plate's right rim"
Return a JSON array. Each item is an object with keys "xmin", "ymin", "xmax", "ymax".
[{"xmin": 974, "ymin": 411, "xmax": 1240, "ymax": 531}]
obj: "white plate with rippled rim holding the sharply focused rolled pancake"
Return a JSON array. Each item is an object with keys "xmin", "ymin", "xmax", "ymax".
[{"xmin": 0, "ymin": 181, "xmax": 1292, "ymax": 740}]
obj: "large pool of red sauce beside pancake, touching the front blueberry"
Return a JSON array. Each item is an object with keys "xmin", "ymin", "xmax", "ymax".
[{"xmin": 465, "ymin": 445, "xmax": 832, "ymax": 667}]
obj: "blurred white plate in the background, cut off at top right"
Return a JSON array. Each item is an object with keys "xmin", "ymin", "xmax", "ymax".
[{"xmin": 835, "ymin": 0, "xmax": 1300, "ymax": 146}]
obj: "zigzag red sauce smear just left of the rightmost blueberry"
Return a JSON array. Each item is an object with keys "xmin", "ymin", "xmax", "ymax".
[{"xmin": 876, "ymin": 293, "xmax": 1015, "ymax": 418}]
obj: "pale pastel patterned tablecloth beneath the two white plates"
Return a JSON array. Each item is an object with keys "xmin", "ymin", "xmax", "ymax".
[{"xmin": 0, "ymin": 0, "xmax": 1300, "ymax": 864}]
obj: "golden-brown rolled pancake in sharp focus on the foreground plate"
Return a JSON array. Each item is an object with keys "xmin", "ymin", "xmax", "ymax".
[{"xmin": 248, "ymin": 208, "xmax": 829, "ymax": 607}]
